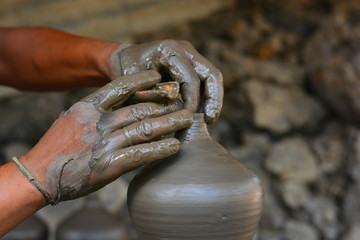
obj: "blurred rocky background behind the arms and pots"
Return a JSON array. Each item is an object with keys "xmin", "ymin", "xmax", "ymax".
[{"xmin": 0, "ymin": 0, "xmax": 360, "ymax": 240}]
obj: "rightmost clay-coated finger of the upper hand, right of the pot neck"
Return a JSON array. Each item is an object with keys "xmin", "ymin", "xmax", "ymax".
[{"xmin": 180, "ymin": 41, "xmax": 224, "ymax": 124}]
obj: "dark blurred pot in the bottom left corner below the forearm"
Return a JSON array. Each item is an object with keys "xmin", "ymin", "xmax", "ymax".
[{"xmin": 1, "ymin": 215, "xmax": 48, "ymax": 240}]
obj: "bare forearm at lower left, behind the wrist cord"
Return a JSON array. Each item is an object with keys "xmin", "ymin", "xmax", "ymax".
[{"xmin": 0, "ymin": 159, "xmax": 45, "ymax": 238}]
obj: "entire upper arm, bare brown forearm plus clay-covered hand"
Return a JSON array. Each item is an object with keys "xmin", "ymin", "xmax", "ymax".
[{"xmin": 0, "ymin": 28, "xmax": 223, "ymax": 123}]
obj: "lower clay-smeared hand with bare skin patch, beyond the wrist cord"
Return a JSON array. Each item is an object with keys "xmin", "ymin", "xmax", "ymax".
[{"xmin": 20, "ymin": 71, "xmax": 192, "ymax": 203}]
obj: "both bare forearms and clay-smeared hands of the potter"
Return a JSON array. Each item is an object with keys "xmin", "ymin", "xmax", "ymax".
[{"xmin": 0, "ymin": 27, "xmax": 223, "ymax": 237}]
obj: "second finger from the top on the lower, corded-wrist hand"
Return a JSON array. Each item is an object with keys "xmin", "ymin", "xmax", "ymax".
[{"xmin": 101, "ymin": 101, "xmax": 182, "ymax": 131}]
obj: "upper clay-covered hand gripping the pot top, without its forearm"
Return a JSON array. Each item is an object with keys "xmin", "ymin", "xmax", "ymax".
[{"xmin": 111, "ymin": 40, "xmax": 223, "ymax": 124}]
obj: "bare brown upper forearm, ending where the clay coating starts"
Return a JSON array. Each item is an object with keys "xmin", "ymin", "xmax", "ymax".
[{"xmin": 0, "ymin": 28, "xmax": 119, "ymax": 91}]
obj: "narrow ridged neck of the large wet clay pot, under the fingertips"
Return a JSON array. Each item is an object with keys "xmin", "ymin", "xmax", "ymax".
[{"xmin": 179, "ymin": 113, "xmax": 210, "ymax": 142}]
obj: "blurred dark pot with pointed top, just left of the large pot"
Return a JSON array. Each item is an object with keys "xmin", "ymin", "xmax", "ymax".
[{"xmin": 56, "ymin": 195, "xmax": 130, "ymax": 240}]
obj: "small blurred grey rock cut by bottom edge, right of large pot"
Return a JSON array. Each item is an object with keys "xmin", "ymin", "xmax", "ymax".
[{"xmin": 284, "ymin": 220, "xmax": 319, "ymax": 240}]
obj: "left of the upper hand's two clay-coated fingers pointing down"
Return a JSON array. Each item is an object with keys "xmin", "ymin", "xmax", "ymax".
[{"xmin": 159, "ymin": 40, "xmax": 200, "ymax": 112}]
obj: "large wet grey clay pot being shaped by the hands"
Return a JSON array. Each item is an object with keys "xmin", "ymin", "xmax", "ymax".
[{"xmin": 128, "ymin": 114, "xmax": 263, "ymax": 240}]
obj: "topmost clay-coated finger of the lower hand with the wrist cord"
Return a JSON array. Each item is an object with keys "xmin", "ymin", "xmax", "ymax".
[{"xmin": 84, "ymin": 70, "xmax": 161, "ymax": 109}]
